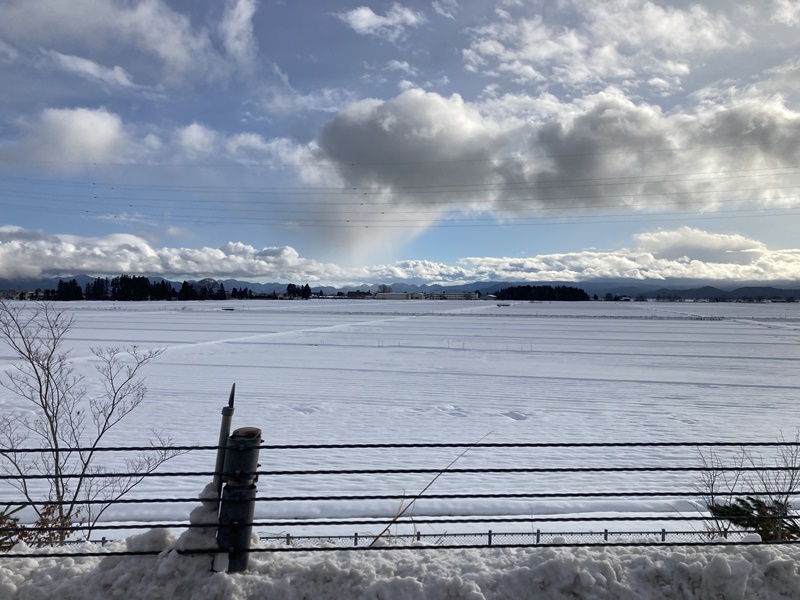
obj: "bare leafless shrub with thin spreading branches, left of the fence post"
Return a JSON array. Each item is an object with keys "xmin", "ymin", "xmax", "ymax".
[{"xmin": 0, "ymin": 301, "xmax": 183, "ymax": 545}]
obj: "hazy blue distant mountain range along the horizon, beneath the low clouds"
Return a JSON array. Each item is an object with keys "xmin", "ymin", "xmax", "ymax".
[{"xmin": 0, "ymin": 275, "xmax": 800, "ymax": 300}]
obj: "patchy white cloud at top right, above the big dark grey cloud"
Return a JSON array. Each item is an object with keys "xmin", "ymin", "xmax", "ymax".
[{"xmin": 462, "ymin": 0, "xmax": 751, "ymax": 93}]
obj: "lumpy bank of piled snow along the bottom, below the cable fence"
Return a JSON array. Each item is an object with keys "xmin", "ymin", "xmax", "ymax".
[{"xmin": 0, "ymin": 531, "xmax": 800, "ymax": 600}]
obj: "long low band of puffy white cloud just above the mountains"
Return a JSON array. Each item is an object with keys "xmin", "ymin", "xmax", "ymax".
[{"xmin": 0, "ymin": 226, "xmax": 800, "ymax": 285}]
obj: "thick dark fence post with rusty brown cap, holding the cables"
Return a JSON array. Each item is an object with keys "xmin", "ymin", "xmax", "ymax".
[{"xmin": 217, "ymin": 427, "xmax": 261, "ymax": 573}]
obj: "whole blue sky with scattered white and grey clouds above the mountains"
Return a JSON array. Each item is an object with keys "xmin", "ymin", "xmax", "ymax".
[{"xmin": 0, "ymin": 0, "xmax": 800, "ymax": 285}]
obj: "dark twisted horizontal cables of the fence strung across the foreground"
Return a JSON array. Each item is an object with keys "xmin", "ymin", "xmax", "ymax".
[{"xmin": 0, "ymin": 441, "xmax": 800, "ymax": 558}]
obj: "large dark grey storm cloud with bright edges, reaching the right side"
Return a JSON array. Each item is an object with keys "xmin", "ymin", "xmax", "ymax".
[{"xmin": 304, "ymin": 89, "xmax": 800, "ymax": 227}]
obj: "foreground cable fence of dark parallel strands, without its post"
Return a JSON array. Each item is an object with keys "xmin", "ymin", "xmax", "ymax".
[{"xmin": 0, "ymin": 442, "xmax": 800, "ymax": 556}]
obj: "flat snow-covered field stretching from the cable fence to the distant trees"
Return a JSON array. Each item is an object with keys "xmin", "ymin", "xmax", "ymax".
[{"xmin": 0, "ymin": 300, "xmax": 800, "ymax": 534}]
